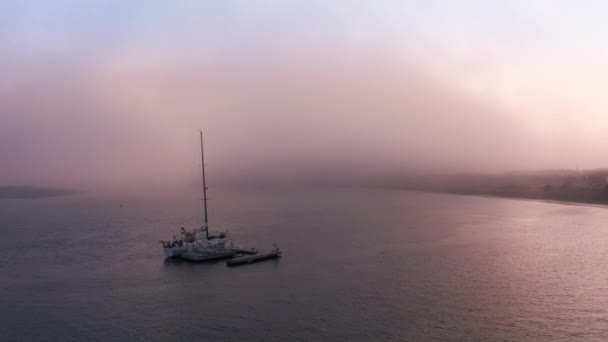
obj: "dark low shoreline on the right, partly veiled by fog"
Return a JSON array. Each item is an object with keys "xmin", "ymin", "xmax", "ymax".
[{"xmin": 399, "ymin": 169, "xmax": 608, "ymax": 204}]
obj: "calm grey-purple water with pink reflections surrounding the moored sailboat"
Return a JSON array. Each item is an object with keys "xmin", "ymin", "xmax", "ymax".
[{"xmin": 0, "ymin": 189, "xmax": 608, "ymax": 342}]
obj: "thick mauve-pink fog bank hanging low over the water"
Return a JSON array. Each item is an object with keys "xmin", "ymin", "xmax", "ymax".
[{"xmin": 0, "ymin": 51, "xmax": 530, "ymax": 190}]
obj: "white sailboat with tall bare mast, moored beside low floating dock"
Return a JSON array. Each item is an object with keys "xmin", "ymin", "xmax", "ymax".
[{"xmin": 159, "ymin": 131, "xmax": 227, "ymax": 257}]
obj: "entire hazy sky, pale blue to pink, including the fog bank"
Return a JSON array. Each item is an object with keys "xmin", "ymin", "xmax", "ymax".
[{"xmin": 0, "ymin": 1, "xmax": 608, "ymax": 186}]
